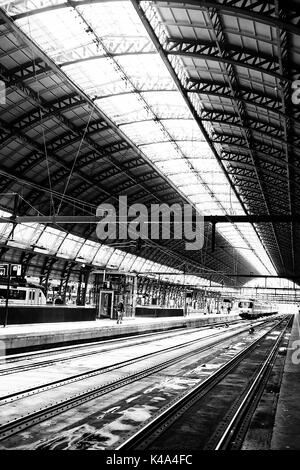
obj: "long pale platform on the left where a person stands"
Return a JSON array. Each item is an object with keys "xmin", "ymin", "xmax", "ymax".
[{"xmin": 0, "ymin": 314, "xmax": 239, "ymax": 355}]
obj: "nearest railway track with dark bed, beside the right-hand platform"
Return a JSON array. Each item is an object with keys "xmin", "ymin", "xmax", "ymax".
[{"xmin": 115, "ymin": 317, "xmax": 292, "ymax": 451}]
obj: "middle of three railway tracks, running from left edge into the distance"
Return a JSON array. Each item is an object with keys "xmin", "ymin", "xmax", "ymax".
[{"xmin": 0, "ymin": 316, "xmax": 276, "ymax": 440}]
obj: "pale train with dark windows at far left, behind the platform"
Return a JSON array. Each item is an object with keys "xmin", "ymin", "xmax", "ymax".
[{"xmin": 0, "ymin": 282, "xmax": 46, "ymax": 307}]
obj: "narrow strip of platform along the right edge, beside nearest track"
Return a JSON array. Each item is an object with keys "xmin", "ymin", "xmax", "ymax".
[{"xmin": 271, "ymin": 314, "xmax": 300, "ymax": 450}]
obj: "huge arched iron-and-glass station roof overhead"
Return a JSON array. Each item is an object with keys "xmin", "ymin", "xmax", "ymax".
[{"xmin": 0, "ymin": 0, "xmax": 300, "ymax": 283}]
